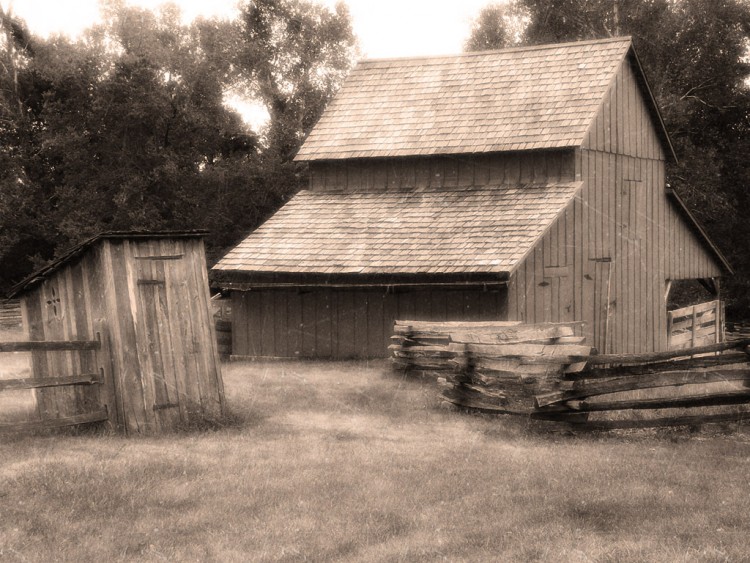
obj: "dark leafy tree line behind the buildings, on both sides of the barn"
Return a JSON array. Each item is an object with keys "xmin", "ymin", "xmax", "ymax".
[{"xmin": 0, "ymin": 0, "xmax": 750, "ymax": 317}]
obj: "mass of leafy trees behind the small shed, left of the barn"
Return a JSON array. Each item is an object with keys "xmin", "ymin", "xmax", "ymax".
[{"xmin": 0, "ymin": 0, "xmax": 354, "ymax": 289}]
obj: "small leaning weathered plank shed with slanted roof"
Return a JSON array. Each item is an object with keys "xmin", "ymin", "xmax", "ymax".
[{"xmin": 12, "ymin": 231, "xmax": 224, "ymax": 433}]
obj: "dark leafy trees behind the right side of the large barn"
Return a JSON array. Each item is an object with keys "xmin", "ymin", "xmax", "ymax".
[{"xmin": 467, "ymin": 0, "xmax": 750, "ymax": 317}]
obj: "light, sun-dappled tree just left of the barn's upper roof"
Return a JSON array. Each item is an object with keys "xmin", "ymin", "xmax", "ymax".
[{"xmin": 234, "ymin": 0, "xmax": 356, "ymax": 159}]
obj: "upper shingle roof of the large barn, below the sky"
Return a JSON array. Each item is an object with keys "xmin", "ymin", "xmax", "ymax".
[{"xmin": 297, "ymin": 38, "xmax": 631, "ymax": 160}]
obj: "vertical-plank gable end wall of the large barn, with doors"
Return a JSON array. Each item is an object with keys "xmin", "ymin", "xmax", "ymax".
[{"xmin": 509, "ymin": 58, "xmax": 721, "ymax": 353}]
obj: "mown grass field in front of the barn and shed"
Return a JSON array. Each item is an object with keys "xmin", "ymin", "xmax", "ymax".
[{"xmin": 0, "ymin": 350, "xmax": 750, "ymax": 562}]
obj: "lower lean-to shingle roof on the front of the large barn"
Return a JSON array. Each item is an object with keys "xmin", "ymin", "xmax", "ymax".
[{"xmin": 214, "ymin": 182, "xmax": 581, "ymax": 274}]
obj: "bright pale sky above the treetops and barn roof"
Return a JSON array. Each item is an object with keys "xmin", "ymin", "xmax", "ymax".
[{"xmin": 5, "ymin": 0, "xmax": 502, "ymax": 58}]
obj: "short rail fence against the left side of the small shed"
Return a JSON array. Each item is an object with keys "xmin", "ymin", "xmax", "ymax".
[{"xmin": 0, "ymin": 332, "xmax": 109, "ymax": 434}]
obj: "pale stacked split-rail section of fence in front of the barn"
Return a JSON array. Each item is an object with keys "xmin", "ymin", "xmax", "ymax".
[{"xmin": 390, "ymin": 321, "xmax": 591, "ymax": 414}]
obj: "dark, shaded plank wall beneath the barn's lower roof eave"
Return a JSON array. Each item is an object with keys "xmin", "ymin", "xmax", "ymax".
[{"xmin": 232, "ymin": 288, "xmax": 507, "ymax": 359}]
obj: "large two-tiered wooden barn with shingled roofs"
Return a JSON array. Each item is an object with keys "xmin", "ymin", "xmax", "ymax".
[{"xmin": 212, "ymin": 38, "xmax": 731, "ymax": 358}]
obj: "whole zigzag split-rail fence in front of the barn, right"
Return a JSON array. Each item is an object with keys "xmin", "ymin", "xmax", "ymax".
[{"xmin": 390, "ymin": 321, "xmax": 750, "ymax": 430}]
